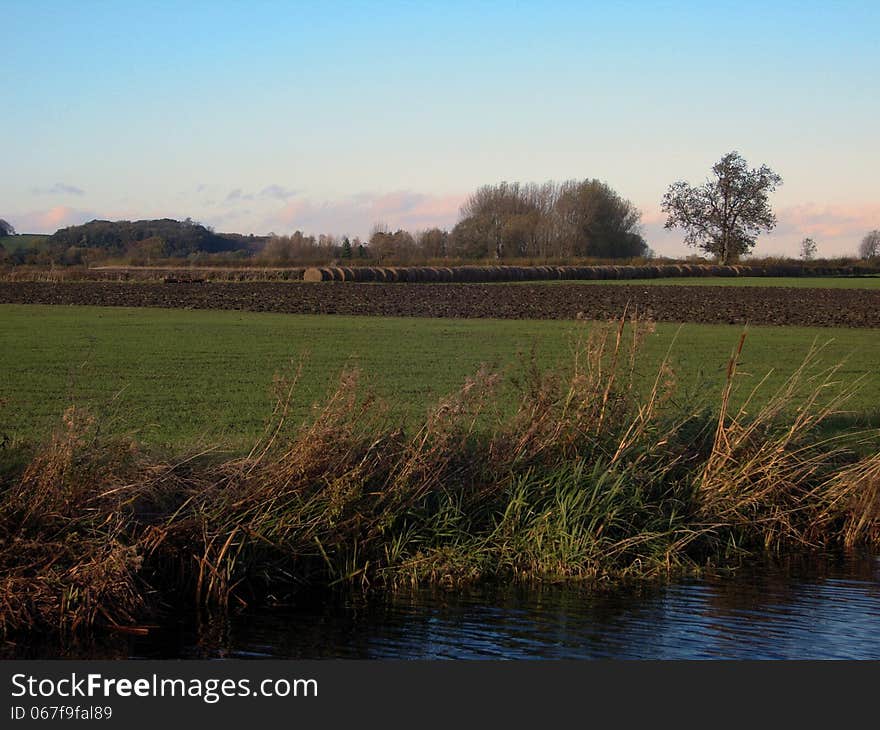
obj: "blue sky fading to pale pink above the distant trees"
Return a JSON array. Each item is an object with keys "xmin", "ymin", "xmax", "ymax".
[{"xmin": 0, "ymin": 0, "xmax": 880, "ymax": 256}]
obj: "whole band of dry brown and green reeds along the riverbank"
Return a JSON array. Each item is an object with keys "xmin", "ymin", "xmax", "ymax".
[{"xmin": 0, "ymin": 313, "xmax": 880, "ymax": 633}]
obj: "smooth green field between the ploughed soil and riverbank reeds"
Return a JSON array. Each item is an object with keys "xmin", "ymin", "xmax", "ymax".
[{"xmin": 0, "ymin": 305, "xmax": 880, "ymax": 451}]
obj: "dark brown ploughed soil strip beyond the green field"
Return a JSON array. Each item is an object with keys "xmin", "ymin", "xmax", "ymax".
[{"xmin": 0, "ymin": 282, "xmax": 880, "ymax": 327}]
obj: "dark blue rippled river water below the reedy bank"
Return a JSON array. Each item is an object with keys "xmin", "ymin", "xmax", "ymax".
[{"xmin": 113, "ymin": 556, "xmax": 880, "ymax": 659}]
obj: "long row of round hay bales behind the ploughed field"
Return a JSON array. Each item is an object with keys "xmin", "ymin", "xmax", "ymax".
[{"xmin": 303, "ymin": 264, "xmax": 868, "ymax": 283}]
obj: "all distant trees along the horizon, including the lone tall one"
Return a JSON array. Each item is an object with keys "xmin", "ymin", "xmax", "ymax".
[{"xmin": 0, "ymin": 159, "xmax": 880, "ymax": 265}]
